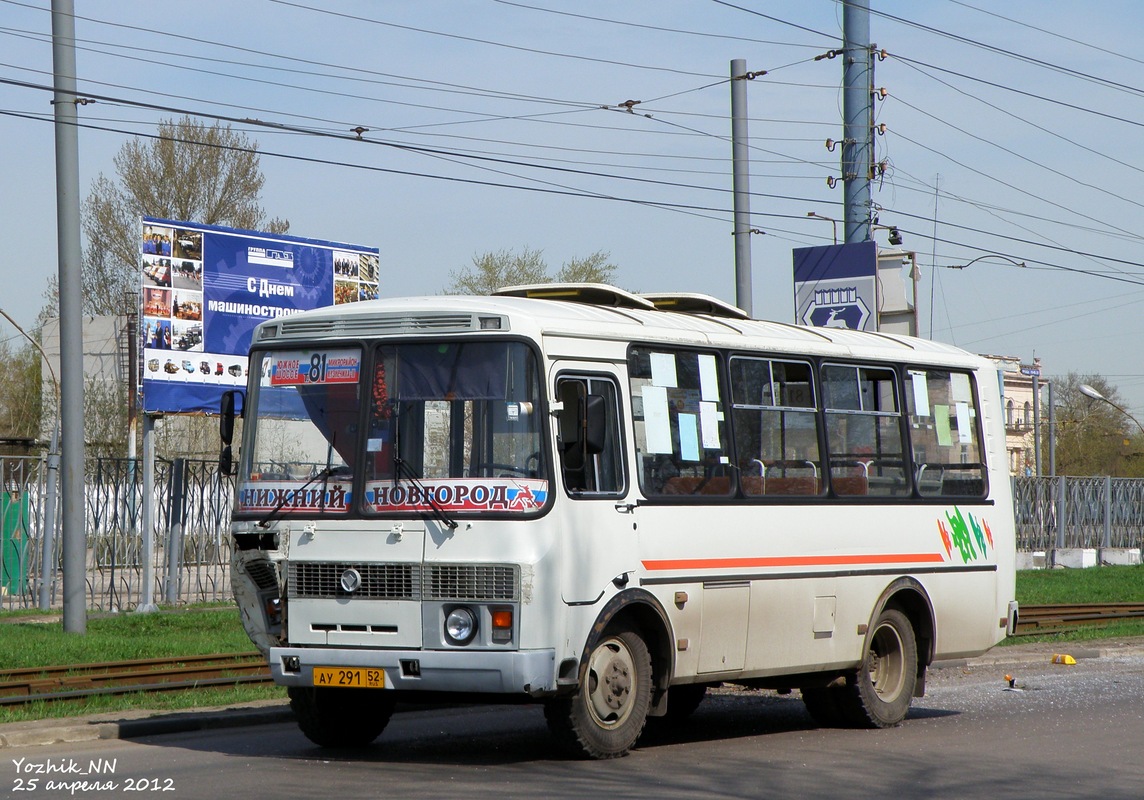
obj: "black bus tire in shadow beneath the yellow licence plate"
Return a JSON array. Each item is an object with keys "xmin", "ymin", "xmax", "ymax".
[{"xmin": 287, "ymin": 687, "xmax": 396, "ymax": 747}]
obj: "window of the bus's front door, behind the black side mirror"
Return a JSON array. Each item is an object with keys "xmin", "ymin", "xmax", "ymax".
[{"xmin": 556, "ymin": 375, "xmax": 625, "ymax": 498}]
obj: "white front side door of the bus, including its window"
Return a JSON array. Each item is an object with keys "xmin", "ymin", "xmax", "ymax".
[{"xmin": 555, "ymin": 373, "xmax": 638, "ymax": 603}]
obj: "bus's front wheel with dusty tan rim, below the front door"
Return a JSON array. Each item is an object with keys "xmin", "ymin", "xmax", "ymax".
[{"xmin": 545, "ymin": 628, "xmax": 651, "ymax": 759}]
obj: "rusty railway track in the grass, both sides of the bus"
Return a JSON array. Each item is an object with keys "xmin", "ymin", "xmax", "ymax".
[{"xmin": 0, "ymin": 603, "xmax": 1144, "ymax": 706}]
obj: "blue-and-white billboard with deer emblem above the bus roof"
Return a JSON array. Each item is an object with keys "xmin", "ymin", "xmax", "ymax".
[{"xmin": 794, "ymin": 241, "xmax": 877, "ymax": 331}]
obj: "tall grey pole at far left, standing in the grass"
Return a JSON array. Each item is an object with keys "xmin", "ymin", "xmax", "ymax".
[{"xmin": 51, "ymin": 0, "xmax": 87, "ymax": 633}]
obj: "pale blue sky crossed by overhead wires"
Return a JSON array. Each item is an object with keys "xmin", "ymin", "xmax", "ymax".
[{"xmin": 0, "ymin": 0, "xmax": 1144, "ymax": 417}]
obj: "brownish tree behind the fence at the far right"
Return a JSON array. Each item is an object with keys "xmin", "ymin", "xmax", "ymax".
[{"xmin": 1042, "ymin": 372, "xmax": 1144, "ymax": 477}]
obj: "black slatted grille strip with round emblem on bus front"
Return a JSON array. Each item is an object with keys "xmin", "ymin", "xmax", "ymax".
[{"xmin": 287, "ymin": 561, "xmax": 521, "ymax": 601}]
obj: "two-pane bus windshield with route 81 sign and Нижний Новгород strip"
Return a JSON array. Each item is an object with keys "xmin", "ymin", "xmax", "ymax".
[{"xmin": 237, "ymin": 341, "xmax": 548, "ymax": 515}]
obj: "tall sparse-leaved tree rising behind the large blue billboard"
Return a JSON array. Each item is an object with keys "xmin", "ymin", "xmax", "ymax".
[{"xmin": 56, "ymin": 117, "xmax": 289, "ymax": 315}]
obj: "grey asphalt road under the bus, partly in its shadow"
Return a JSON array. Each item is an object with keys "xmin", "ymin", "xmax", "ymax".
[{"xmin": 0, "ymin": 642, "xmax": 1144, "ymax": 800}]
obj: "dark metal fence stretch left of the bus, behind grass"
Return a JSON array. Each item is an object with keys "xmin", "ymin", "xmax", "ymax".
[{"xmin": 0, "ymin": 458, "xmax": 232, "ymax": 611}]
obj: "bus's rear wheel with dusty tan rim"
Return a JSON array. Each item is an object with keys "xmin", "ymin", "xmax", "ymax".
[{"xmin": 839, "ymin": 609, "xmax": 917, "ymax": 728}]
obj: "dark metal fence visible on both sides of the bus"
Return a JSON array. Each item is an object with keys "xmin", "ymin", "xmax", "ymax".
[{"xmin": 0, "ymin": 469, "xmax": 1144, "ymax": 611}]
